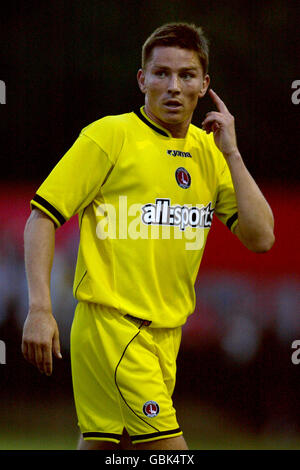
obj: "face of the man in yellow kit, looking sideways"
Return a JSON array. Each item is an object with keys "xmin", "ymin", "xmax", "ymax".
[{"xmin": 138, "ymin": 47, "xmax": 209, "ymax": 137}]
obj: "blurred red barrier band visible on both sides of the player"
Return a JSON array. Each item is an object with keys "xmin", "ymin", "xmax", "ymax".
[{"xmin": 0, "ymin": 183, "xmax": 300, "ymax": 275}]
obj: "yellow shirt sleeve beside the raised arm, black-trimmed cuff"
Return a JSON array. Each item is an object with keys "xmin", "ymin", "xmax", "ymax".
[{"xmin": 215, "ymin": 161, "xmax": 238, "ymax": 231}]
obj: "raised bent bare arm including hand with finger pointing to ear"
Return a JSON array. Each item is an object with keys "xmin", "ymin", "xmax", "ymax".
[{"xmin": 202, "ymin": 90, "xmax": 275, "ymax": 253}]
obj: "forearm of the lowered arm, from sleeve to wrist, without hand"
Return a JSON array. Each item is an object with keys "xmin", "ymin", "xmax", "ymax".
[{"xmin": 24, "ymin": 210, "xmax": 55, "ymax": 311}]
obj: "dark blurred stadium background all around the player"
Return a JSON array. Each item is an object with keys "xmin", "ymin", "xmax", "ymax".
[{"xmin": 0, "ymin": 0, "xmax": 300, "ymax": 450}]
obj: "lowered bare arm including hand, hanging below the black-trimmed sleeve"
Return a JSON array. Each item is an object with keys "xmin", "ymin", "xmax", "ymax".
[{"xmin": 22, "ymin": 209, "xmax": 61, "ymax": 375}]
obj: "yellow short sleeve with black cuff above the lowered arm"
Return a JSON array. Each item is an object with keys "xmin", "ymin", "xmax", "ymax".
[{"xmin": 30, "ymin": 133, "xmax": 113, "ymax": 227}]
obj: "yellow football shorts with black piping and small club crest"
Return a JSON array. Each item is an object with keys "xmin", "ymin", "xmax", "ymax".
[{"xmin": 71, "ymin": 302, "xmax": 182, "ymax": 443}]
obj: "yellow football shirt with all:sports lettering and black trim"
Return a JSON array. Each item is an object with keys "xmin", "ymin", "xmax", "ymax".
[{"xmin": 31, "ymin": 108, "xmax": 237, "ymax": 327}]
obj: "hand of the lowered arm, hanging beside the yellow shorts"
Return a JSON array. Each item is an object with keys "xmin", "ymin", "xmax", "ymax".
[{"xmin": 22, "ymin": 311, "xmax": 62, "ymax": 375}]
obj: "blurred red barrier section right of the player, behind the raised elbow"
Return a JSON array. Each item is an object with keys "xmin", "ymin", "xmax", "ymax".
[{"xmin": 201, "ymin": 185, "xmax": 300, "ymax": 275}]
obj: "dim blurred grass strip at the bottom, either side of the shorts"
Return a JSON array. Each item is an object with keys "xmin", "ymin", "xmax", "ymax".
[{"xmin": 0, "ymin": 397, "xmax": 300, "ymax": 450}]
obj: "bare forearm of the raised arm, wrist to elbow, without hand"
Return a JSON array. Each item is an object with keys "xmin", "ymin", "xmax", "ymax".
[{"xmin": 225, "ymin": 152, "xmax": 275, "ymax": 252}]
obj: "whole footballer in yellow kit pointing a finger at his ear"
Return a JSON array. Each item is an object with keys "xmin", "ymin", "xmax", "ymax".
[{"xmin": 22, "ymin": 23, "xmax": 274, "ymax": 450}]
